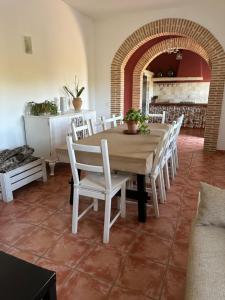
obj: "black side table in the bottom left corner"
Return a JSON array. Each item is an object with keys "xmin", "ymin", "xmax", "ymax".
[{"xmin": 0, "ymin": 251, "xmax": 57, "ymax": 300}]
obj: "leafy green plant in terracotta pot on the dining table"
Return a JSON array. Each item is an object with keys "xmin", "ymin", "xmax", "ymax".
[{"xmin": 124, "ymin": 108, "xmax": 150, "ymax": 134}]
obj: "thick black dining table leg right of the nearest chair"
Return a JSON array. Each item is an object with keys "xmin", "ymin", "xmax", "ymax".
[{"xmin": 137, "ymin": 174, "xmax": 147, "ymax": 223}]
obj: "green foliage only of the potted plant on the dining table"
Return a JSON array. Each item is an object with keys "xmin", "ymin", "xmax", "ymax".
[{"xmin": 124, "ymin": 108, "xmax": 150, "ymax": 134}]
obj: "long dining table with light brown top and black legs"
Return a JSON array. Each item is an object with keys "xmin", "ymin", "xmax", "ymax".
[{"xmin": 56, "ymin": 123, "xmax": 170, "ymax": 222}]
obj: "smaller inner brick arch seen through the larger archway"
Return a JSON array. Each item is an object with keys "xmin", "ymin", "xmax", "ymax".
[{"xmin": 132, "ymin": 37, "xmax": 210, "ymax": 109}]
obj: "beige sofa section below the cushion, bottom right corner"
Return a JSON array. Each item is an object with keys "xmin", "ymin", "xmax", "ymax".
[{"xmin": 185, "ymin": 225, "xmax": 225, "ymax": 300}]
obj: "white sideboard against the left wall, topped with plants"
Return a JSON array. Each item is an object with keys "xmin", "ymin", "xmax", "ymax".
[{"xmin": 24, "ymin": 110, "xmax": 96, "ymax": 175}]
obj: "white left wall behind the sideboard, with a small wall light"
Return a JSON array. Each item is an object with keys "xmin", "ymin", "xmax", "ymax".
[{"xmin": 0, "ymin": 0, "xmax": 94, "ymax": 149}]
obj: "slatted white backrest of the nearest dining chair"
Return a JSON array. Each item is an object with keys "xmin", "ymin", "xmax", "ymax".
[{"xmin": 66, "ymin": 136, "xmax": 111, "ymax": 191}]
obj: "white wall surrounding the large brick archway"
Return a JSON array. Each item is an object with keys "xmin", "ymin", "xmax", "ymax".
[{"xmin": 95, "ymin": 0, "xmax": 225, "ymax": 149}]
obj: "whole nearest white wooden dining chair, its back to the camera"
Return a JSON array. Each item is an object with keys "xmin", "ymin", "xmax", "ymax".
[{"xmin": 66, "ymin": 136, "xmax": 128, "ymax": 243}]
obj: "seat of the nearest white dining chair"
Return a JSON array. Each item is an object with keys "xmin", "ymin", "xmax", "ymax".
[{"xmin": 79, "ymin": 173, "xmax": 129, "ymax": 194}]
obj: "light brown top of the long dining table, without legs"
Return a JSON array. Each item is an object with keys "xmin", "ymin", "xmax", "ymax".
[{"xmin": 56, "ymin": 124, "xmax": 170, "ymax": 175}]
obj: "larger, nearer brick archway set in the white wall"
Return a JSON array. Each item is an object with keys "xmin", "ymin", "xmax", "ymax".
[{"xmin": 111, "ymin": 18, "xmax": 225, "ymax": 151}]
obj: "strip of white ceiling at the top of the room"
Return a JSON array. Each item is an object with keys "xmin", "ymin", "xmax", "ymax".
[{"xmin": 64, "ymin": 0, "xmax": 194, "ymax": 19}]
